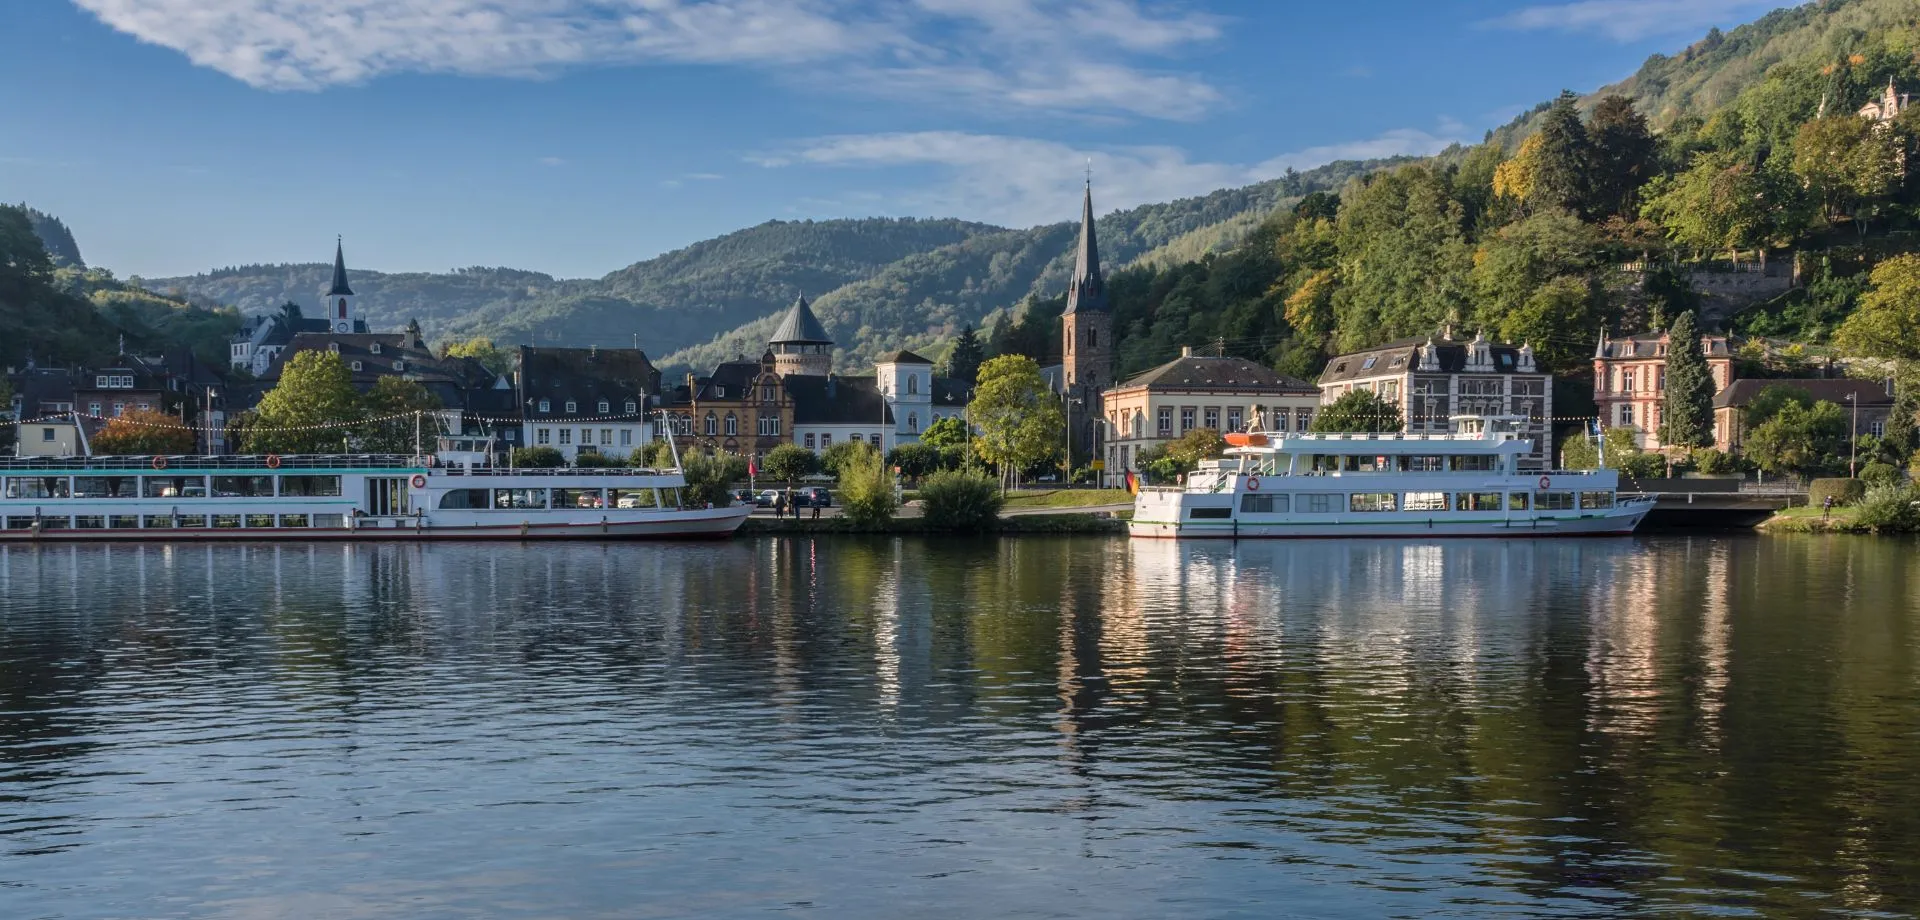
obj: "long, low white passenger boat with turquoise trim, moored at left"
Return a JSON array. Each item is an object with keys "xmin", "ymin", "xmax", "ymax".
[{"xmin": 0, "ymin": 445, "xmax": 753, "ymax": 544}]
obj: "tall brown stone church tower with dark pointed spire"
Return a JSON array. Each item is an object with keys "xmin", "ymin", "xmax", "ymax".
[{"xmin": 1060, "ymin": 181, "xmax": 1114, "ymax": 482}]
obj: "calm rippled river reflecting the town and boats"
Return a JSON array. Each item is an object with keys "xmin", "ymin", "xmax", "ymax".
[{"xmin": 0, "ymin": 536, "xmax": 1920, "ymax": 920}]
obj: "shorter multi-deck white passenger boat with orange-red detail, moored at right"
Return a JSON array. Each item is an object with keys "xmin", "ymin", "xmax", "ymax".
[{"xmin": 1129, "ymin": 417, "xmax": 1653, "ymax": 540}]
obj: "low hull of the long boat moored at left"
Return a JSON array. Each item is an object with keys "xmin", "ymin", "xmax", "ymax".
[{"xmin": 0, "ymin": 505, "xmax": 753, "ymax": 544}]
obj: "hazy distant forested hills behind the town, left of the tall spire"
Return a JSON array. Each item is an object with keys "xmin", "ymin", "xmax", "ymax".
[{"xmin": 146, "ymin": 219, "xmax": 1000, "ymax": 353}]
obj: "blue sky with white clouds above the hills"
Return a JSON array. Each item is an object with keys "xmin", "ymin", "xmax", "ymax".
[{"xmin": 0, "ymin": 0, "xmax": 1778, "ymax": 277}]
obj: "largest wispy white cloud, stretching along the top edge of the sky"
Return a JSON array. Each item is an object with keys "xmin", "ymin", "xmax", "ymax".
[{"xmin": 73, "ymin": 0, "xmax": 1221, "ymax": 117}]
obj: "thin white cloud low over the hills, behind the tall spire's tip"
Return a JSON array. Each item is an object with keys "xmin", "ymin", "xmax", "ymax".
[{"xmin": 755, "ymin": 123, "xmax": 1465, "ymax": 227}]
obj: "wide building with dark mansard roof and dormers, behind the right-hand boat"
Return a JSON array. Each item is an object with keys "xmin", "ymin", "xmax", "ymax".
[{"xmin": 1319, "ymin": 328, "xmax": 1553, "ymax": 469}]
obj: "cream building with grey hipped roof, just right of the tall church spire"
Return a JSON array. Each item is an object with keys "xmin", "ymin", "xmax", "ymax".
[{"xmin": 1102, "ymin": 348, "xmax": 1319, "ymax": 482}]
